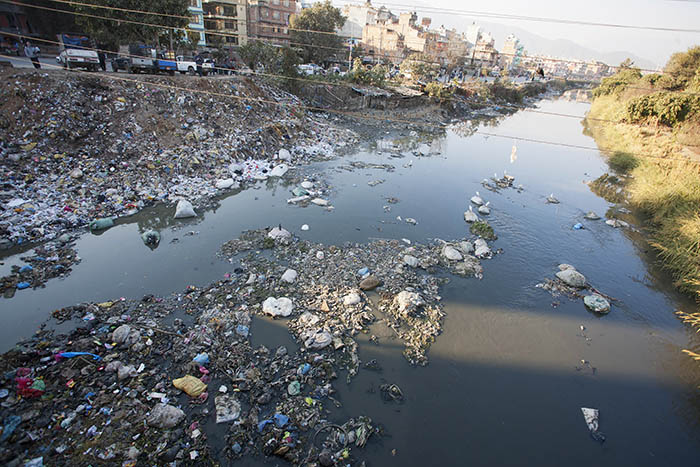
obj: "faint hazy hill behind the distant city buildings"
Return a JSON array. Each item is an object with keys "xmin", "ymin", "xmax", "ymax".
[{"xmin": 477, "ymin": 22, "xmax": 658, "ymax": 70}]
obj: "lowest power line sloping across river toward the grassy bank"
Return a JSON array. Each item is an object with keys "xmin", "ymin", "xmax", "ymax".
[{"xmin": 0, "ymin": 51, "xmax": 700, "ymax": 166}]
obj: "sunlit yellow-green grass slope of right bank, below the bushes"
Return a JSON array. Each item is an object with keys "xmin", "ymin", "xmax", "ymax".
[{"xmin": 585, "ymin": 89, "xmax": 700, "ymax": 310}]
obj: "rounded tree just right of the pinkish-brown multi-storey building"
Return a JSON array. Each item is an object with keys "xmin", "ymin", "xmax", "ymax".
[{"xmin": 291, "ymin": 0, "xmax": 345, "ymax": 63}]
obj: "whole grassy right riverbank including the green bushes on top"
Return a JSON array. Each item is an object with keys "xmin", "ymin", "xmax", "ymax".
[{"xmin": 585, "ymin": 47, "xmax": 700, "ymax": 310}]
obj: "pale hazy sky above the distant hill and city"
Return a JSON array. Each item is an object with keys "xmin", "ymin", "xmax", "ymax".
[{"xmin": 333, "ymin": 0, "xmax": 700, "ymax": 65}]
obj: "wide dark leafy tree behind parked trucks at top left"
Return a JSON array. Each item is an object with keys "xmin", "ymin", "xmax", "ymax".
[{"xmin": 72, "ymin": 0, "xmax": 191, "ymax": 46}]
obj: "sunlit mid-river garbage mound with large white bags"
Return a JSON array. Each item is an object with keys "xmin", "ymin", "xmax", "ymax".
[{"xmin": 221, "ymin": 225, "xmax": 490, "ymax": 366}]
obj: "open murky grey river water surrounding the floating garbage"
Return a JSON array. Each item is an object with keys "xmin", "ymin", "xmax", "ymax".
[{"xmin": 0, "ymin": 93, "xmax": 700, "ymax": 467}]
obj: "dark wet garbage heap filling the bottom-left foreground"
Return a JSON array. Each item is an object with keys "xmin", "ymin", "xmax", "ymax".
[{"xmin": 0, "ymin": 286, "xmax": 381, "ymax": 466}]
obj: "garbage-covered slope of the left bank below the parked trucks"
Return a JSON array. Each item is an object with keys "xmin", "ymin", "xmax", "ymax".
[{"xmin": 0, "ymin": 70, "xmax": 357, "ymax": 248}]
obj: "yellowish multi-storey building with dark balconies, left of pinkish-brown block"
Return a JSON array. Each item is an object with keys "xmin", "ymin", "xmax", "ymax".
[{"xmin": 202, "ymin": 0, "xmax": 248, "ymax": 47}]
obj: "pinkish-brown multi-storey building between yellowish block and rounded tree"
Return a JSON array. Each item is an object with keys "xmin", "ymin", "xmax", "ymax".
[{"xmin": 247, "ymin": 0, "xmax": 297, "ymax": 45}]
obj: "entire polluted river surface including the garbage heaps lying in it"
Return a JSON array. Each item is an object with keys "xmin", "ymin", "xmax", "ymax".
[{"xmin": 0, "ymin": 99, "xmax": 700, "ymax": 467}]
